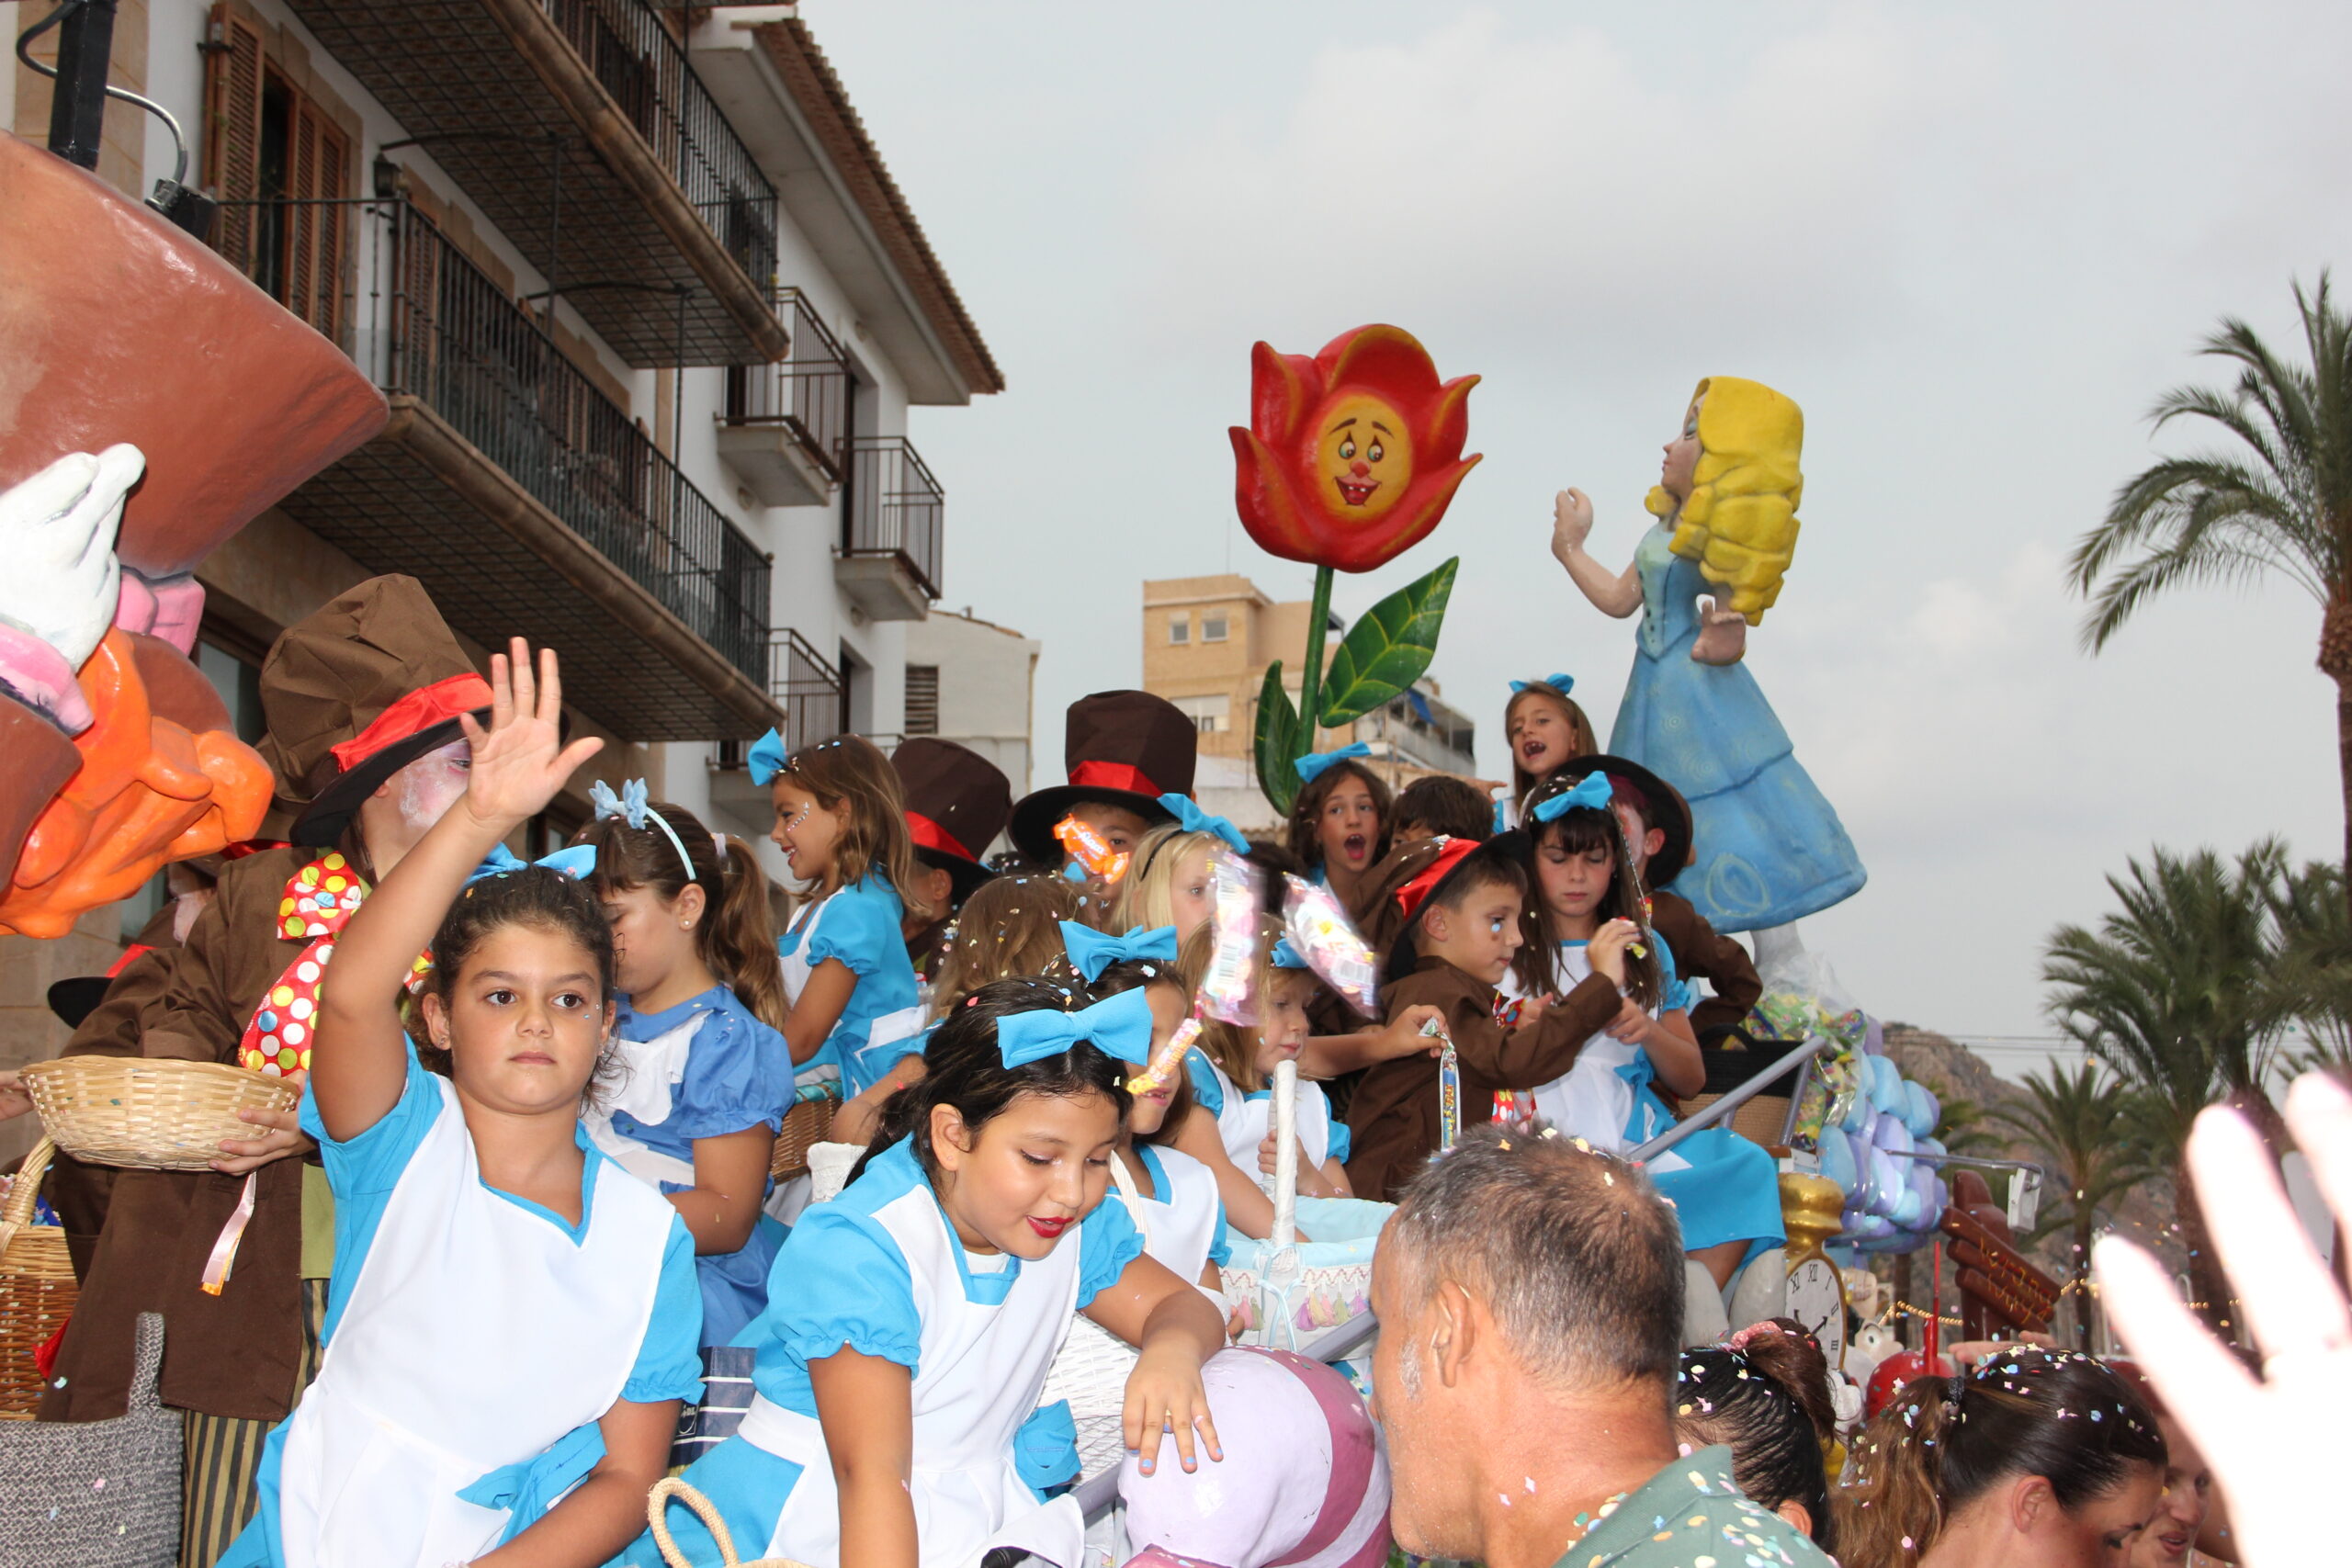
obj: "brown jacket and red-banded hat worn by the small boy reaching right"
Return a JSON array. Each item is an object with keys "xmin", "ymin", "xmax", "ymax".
[{"xmin": 1348, "ymin": 835, "xmax": 1623, "ymax": 1203}]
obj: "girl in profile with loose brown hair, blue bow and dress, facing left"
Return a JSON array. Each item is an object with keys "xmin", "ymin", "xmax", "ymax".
[{"xmin": 748, "ymin": 731, "xmax": 929, "ymax": 1100}]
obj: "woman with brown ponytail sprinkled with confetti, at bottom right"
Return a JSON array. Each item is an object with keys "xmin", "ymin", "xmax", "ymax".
[{"xmin": 1835, "ymin": 1347, "xmax": 2166, "ymax": 1568}]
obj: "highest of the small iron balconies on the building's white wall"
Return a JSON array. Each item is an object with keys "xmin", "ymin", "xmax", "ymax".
[{"xmin": 719, "ymin": 289, "xmax": 849, "ymax": 505}]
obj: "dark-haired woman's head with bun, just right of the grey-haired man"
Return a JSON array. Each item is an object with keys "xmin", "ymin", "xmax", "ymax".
[{"xmin": 1675, "ymin": 1316, "xmax": 1837, "ymax": 1551}]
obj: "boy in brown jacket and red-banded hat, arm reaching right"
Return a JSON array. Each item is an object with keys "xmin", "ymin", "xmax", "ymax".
[{"xmin": 1348, "ymin": 832, "xmax": 1623, "ymax": 1201}]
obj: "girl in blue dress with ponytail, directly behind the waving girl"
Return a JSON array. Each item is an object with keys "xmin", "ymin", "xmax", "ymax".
[{"xmin": 576, "ymin": 778, "xmax": 793, "ymax": 1345}]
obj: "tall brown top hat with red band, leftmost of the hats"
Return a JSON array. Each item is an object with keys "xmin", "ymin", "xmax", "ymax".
[{"xmin": 261, "ymin": 576, "xmax": 489, "ymax": 844}]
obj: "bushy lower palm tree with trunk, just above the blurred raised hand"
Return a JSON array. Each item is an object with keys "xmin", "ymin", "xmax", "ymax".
[{"xmin": 2041, "ymin": 840, "xmax": 2290, "ymax": 1324}]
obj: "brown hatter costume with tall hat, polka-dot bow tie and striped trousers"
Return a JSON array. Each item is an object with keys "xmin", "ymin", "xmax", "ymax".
[{"xmin": 40, "ymin": 576, "xmax": 489, "ymax": 1563}]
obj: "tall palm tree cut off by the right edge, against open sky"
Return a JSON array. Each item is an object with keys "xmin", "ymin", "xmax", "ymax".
[{"xmin": 2067, "ymin": 270, "xmax": 2352, "ymax": 894}]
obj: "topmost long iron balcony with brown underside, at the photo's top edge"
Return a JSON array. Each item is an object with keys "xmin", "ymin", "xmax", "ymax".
[{"xmin": 289, "ymin": 0, "xmax": 786, "ymax": 367}]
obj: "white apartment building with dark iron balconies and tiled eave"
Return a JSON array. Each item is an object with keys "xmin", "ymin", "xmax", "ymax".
[{"xmin": 0, "ymin": 0, "xmax": 1001, "ymax": 1104}]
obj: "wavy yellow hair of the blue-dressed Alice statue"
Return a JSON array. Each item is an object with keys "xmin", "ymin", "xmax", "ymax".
[{"xmin": 1644, "ymin": 376, "xmax": 1804, "ymax": 626}]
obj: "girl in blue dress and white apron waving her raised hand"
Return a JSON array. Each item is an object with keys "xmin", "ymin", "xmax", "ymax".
[{"xmin": 221, "ymin": 639, "xmax": 701, "ymax": 1568}]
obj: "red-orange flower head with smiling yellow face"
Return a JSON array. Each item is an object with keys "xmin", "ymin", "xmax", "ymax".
[{"xmin": 1232, "ymin": 327, "xmax": 1479, "ymax": 571}]
